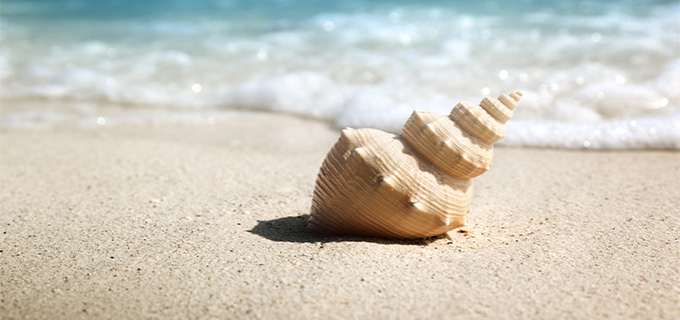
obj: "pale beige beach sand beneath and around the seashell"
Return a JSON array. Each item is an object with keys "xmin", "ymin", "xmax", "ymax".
[{"xmin": 0, "ymin": 112, "xmax": 680, "ymax": 319}]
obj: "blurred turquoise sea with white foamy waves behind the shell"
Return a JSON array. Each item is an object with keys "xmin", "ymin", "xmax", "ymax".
[{"xmin": 0, "ymin": 0, "xmax": 680, "ymax": 149}]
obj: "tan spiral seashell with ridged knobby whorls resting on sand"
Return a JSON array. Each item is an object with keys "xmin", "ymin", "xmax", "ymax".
[{"xmin": 307, "ymin": 92, "xmax": 522, "ymax": 239}]
